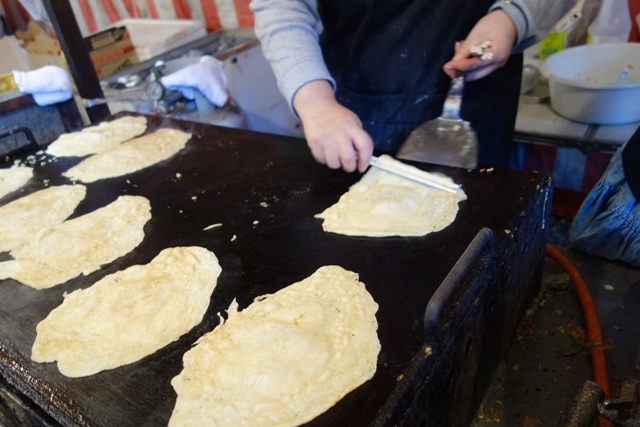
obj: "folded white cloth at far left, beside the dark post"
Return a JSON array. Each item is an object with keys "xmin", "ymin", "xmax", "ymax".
[{"xmin": 13, "ymin": 65, "xmax": 73, "ymax": 106}]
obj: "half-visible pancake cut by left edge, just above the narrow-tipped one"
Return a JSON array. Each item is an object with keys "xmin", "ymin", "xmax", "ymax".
[{"xmin": 0, "ymin": 185, "xmax": 87, "ymax": 252}]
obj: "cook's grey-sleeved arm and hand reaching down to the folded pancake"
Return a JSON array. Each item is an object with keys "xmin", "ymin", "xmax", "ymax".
[{"xmin": 251, "ymin": 0, "xmax": 373, "ymax": 172}]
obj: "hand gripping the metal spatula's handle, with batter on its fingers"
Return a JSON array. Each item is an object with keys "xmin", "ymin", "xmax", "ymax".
[{"xmin": 443, "ymin": 9, "xmax": 517, "ymax": 81}]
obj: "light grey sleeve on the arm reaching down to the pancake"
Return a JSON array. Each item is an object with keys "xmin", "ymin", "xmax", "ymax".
[{"xmin": 250, "ymin": 0, "xmax": 336, "ymax": 112}]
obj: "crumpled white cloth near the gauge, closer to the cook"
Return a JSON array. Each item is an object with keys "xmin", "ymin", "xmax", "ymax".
[{"xmin": 161, "ymin": 56, "xmax": 229, "ymax": 107}]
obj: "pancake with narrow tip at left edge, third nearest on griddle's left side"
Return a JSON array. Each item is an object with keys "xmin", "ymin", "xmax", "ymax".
[{"xmin": 0, "ymin": 196, "xmax": 151, "ymax": 289}]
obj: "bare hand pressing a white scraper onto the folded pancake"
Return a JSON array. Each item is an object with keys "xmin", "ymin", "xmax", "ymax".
[{"xmin": 293, "ymin": 80, "xmax": 373, "ymax": 172}]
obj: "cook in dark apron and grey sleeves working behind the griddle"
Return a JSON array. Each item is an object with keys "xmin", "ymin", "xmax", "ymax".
[{"xmin": 250, "ymin": 0, "xmax": 576, "ymax": 172}]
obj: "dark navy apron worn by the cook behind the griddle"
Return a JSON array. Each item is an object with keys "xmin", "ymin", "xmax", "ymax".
[{"xmin": 318, "ymin": 0, "xmax": 522, "ymax": 166}]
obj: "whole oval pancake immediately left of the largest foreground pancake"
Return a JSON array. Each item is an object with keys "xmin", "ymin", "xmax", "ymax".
[{"xmin": 31, "ymin": 247, "xmax": 221, "ymax": 377}]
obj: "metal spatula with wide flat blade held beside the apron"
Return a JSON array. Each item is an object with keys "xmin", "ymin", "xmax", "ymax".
[{"xmin": 397, "ymin": 75, "xmax": 478, "ymax": 169}]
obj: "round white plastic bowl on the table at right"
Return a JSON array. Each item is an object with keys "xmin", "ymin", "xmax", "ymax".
[{"xmin": 540, "ymin": 43, "xmax": 640, "ymax": 125}]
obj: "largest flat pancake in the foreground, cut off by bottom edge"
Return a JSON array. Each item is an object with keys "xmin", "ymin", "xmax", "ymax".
[{"xmin": 169, "ymin": 266, "xmax": 380, "ymax": 427}]
